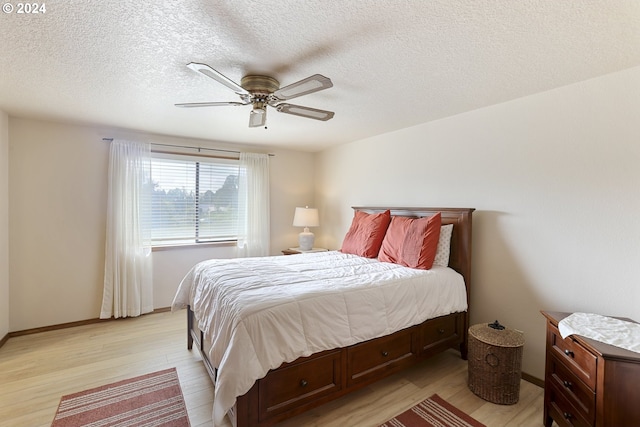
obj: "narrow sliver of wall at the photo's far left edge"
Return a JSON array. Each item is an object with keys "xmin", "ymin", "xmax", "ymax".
[{"xmin": 0, "ymin": 110, "xmax": 9, "ymax": 339}]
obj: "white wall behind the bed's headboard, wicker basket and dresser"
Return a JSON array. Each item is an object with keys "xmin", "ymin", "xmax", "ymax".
[{"xmin": 316, "ymin": 68, "xmax": 640, "ymax": 378}]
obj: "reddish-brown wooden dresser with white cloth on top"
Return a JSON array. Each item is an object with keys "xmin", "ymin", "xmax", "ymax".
[{"xmin": 542, "ymin": 311, "xmax": 640, "ymax": 427}]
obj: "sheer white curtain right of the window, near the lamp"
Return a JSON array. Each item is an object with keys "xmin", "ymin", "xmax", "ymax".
[{"xmin": 238, "ymin": 153, "xmax": 271, "ymax": 257}]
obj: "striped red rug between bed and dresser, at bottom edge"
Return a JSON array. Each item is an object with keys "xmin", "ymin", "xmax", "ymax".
[{"xmin": 380, "ymin": 394, "xmax": 486, "ymax": 427}]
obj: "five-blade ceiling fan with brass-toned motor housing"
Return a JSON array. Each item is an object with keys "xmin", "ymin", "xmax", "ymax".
[{"xmin": 175, "ymin": 62, "xmax": 334, "ymax": 127}]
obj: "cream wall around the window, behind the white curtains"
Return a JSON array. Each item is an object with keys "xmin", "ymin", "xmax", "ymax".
[{"xmin": 6, "ymin": 118, "xmax": 314, "ymax": 331}]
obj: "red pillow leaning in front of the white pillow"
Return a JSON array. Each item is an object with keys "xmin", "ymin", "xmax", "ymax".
[{"xmin": 378, "ymin": 213, "xmax": 442, "ymax": 270}]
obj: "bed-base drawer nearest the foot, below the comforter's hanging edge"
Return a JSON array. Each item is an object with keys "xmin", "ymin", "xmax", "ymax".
[{"xmin": 258, "ymin": 351, "xmax": 342, "ymax": 419}]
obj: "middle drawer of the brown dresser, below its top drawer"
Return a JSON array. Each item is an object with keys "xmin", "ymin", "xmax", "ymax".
[{"xmin": 547, "ymin": 355, "xmax": 596, "ymax": 423}]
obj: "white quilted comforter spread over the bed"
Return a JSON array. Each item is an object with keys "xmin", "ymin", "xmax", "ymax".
[{"xmin": 171, "ymin": 251, "xmax": 467, "ymax": 425}]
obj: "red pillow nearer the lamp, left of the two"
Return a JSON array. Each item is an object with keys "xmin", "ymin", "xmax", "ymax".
[{"xmin": 340, "ymin": 210, "xmax": 391, "ymax": 258}]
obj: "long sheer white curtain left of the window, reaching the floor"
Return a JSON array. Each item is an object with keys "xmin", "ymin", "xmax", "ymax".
[{"xmin": 100, "ymin": 140, "xmax": 153, "ymax": 319}]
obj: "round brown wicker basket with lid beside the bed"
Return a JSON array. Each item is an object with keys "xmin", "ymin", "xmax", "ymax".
[{"xmin": 468, "ymin": 320, "xmax": 524, "ymax": 405}]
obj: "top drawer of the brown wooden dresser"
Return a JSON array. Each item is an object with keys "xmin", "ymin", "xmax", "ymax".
[{"xmin": 548, "ymin": 324, "xmax": 598, "ymax": 390}]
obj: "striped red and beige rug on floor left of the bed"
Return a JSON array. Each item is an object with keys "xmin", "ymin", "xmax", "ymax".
[{"xmin": 51, "ymin": 368, "xmax": 190, "ymax": 427}]
